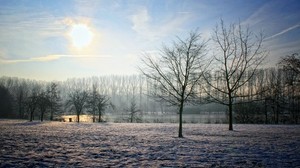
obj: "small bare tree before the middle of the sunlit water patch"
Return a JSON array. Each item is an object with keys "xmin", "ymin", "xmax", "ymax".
[{"xmin": 66, "ymin": 90, "xmax": 88, "ymax": 123}]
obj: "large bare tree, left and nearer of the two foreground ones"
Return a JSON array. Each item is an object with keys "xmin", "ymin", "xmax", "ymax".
[{"xmin": 139, "ymin": 31, "xmax": 207, "ymax": 137}]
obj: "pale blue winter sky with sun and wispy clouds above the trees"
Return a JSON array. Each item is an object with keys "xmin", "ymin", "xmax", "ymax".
[{"xmin": 0, "ymin": 0, "xmax": 300, "ymax": 81}]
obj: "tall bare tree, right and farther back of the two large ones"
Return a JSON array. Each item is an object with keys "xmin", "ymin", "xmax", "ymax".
[{"xmin": 205, "ymin": 20, "xmax": 267, "ymax": 130}]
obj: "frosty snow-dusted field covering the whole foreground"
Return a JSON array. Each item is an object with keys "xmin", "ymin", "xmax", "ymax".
[{"xmin": 0, "ymin": 120, "xmax": 300, "ymax": 167}]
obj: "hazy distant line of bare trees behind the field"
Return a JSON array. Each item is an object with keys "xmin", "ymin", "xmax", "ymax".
[{"xmin": 0, "ymin": 58, "xmax": 300, "ymax": 124}]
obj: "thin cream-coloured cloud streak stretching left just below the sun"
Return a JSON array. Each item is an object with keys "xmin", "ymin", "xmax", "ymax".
[{"xmin": 0, "ymin": 54, "xmax": 111, "ymax": 64}]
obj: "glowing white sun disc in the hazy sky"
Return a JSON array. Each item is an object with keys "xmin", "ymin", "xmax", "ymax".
[{"xmin": 69, "ymin": 24, "xmax": 94, "ymax": 49}]
